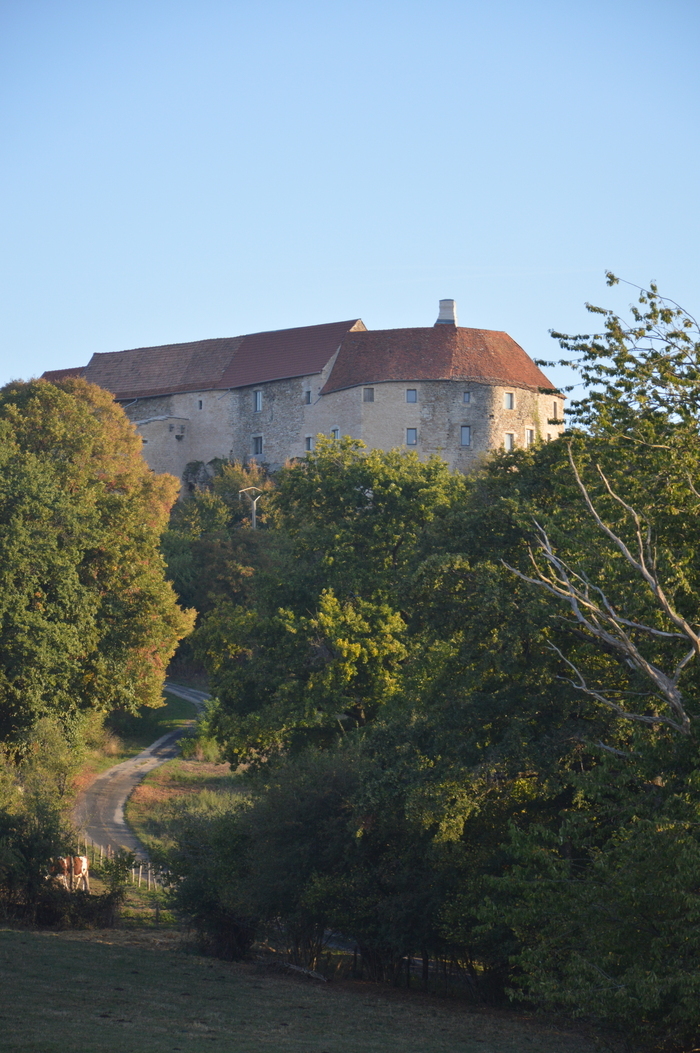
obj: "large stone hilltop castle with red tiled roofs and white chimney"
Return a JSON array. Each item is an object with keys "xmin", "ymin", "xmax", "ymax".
[{"xmin": 44, "ymin": 300, "xmax": 564, "ymax": 478}]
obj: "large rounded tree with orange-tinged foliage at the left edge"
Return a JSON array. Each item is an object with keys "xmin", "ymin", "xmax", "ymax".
[{"xmin": 0, "ymin": 378, "xmax": 193, "ymax": 743}]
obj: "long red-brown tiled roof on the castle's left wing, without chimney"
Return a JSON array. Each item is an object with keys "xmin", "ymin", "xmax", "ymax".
[{"xmin": 43, "ymin": 318, "xmax": 364, "ymax": 399}]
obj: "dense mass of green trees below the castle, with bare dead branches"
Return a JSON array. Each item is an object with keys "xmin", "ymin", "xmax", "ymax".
[{"xmin": 165, "ymin": 279, "xmax": 700, "ymax": 1050}]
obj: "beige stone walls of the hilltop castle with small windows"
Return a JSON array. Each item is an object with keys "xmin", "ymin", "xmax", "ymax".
[{"xmin": 124, "ymin": 374, "xmax": 564, "ymax": 478}]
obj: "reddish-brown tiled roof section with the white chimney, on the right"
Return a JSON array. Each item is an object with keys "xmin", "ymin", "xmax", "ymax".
[{"xmin": 321, "ymin": 325, "xmax": 555, "ymax": 395}]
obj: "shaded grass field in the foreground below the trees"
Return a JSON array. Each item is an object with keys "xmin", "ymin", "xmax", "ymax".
[{"xmin": 0, "ymin": 930, "xmax": 594, "ymax": 1053}]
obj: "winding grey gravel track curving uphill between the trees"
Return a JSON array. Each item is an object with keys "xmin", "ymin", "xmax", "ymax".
[{"xmin": 73, "ymin": 681, "xmax": 211, "ymax": 859}]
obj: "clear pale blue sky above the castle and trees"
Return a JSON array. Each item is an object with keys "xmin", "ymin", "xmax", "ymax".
[{"xmin": 0, "ymin": 0, "xmax": 700, "ymax": 395}]
